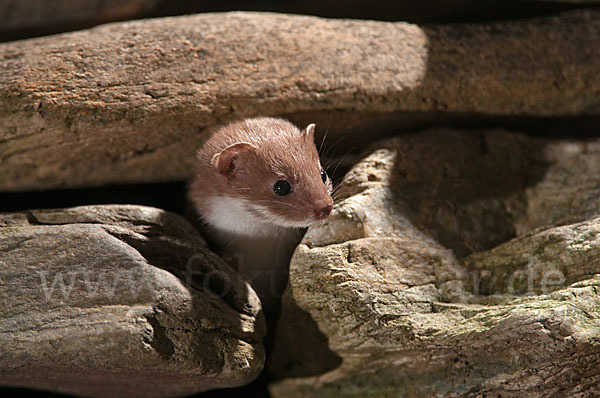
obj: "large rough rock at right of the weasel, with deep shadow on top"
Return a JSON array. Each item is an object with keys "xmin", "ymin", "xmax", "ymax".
[{"xmin": 270, "ymin": 129, "xmax": 600, "ymax": 397}]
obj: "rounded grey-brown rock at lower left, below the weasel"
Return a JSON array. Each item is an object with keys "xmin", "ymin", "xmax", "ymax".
[{"xmin": 0, "ymin": 205, "xmax": 265, "ymax": 397}]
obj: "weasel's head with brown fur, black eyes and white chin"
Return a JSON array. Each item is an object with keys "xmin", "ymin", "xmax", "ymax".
[{"xmin": 192, "ymin": 118, "xmax": 333, "ymax": 235}]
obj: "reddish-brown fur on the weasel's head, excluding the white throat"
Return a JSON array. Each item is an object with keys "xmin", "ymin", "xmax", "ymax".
[{"xmin": 189, "ymin": 118, "xmax": 333, "ymax": 227}]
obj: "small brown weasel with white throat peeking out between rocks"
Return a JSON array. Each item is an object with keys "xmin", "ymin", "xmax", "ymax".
[{"xmin": 188, "ymin": 117, "xmax": 333, "ymax": 312}]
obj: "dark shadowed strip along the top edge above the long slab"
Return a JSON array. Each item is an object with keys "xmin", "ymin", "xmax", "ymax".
[{"xmin": 0, "ymin": 0, "xmax": 598, "ymax": 42}]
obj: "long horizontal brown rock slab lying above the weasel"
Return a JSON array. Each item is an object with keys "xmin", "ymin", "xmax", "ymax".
[{"xmin": 0, "ymin": 10, "xmax": 600, "ymax": 191}]
